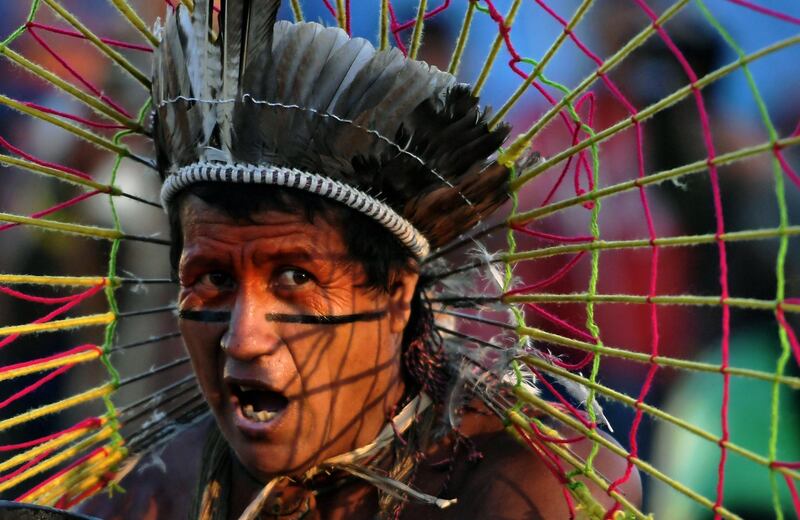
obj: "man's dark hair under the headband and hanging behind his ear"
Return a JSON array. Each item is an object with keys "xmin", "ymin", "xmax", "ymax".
[{"xmin": 168, "ymin": 182, "xmax": 449, "ymax": 402}]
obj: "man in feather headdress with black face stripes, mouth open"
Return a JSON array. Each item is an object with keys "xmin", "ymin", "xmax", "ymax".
[{"xmin": 85, "ymin": 0, "xmax": 639, "ymax": 519}]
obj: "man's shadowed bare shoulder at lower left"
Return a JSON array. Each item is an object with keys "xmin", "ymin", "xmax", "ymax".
[{"xmin": 79, "ymin": 419, "xmax": 212, "ymax": 520}]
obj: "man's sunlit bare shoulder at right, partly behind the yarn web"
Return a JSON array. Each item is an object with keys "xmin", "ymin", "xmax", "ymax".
[{"xmin": 416, "ymin": 416, "xmax": 641, "ymax": 520}]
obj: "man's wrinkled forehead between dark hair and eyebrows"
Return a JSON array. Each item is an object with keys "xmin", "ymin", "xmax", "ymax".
[{"xmin": 179, "ymin": 195, "xmax": 347, "ymax": 254}]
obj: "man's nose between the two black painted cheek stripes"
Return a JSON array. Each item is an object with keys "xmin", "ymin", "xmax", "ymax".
[{"xmin": 220, "ymin": 286, "xmax": 281, "ymax": 361}]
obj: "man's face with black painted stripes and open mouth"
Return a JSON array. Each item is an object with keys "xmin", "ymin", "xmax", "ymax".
[{"xmin": 179, "ymin": 196, "xmax": 416, "ymax": 478}]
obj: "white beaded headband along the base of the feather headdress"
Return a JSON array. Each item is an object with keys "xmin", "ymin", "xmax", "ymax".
[{"xmin": 161, "ymin": 162, "xmax": 430, "ymax": 260}]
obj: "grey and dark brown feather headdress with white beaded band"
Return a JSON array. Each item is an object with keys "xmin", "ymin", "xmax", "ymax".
[{"xmin": 152, "ymin": 0, "xmax": 509, "ymax": 258}]
